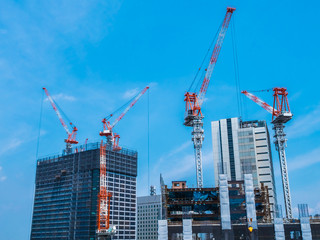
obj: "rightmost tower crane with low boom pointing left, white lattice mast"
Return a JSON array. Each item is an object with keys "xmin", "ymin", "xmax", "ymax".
[{"xmin": 241, "ymin": 87, "xmax": 293, "ymax": 219}]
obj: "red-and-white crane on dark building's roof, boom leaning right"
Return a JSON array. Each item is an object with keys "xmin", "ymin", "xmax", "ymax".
[{"xmin": 100, "ymin": 86, "xmax": 149, "ymax": 151}]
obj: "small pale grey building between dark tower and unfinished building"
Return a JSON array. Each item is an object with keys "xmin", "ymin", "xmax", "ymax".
[{"xmin": 137, "ymin": 190, "xmax": 161, "ymax": 240}]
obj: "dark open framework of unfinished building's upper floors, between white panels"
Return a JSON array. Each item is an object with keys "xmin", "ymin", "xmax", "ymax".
[{"xmin": 162, "ymin": 181, "xmax": 271, "ymax": 224}]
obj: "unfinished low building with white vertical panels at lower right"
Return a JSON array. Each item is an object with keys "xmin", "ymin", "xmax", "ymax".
[{"xmin": 158, "ymin": 174, "xmax": 320, "ymax": 240}]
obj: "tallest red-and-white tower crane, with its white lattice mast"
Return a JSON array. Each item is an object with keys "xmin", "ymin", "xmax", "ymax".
[{"xmin": 184, "ymin": 7, "xmax": 235, "ymax": 188}]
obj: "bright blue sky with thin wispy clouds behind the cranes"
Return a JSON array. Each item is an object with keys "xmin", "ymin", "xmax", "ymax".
[{"xmin": 0, "ymin": 0, "xmax": 320, "ymax": 239}]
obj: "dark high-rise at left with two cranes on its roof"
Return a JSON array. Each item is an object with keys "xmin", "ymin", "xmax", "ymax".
[{"xmin": 31, "ymin": 143, "xmax": 137, "ymax": 240}]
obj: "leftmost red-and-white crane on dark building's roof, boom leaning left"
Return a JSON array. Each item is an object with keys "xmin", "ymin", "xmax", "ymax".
[{"xmin": 42, "ymin": 87, "xmax": 78, "ymax": 154}]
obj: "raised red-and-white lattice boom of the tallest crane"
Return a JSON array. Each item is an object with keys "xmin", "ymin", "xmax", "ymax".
[{"xmin": 198, "ymin": 7, "xmax": 236, "ymax": 107}]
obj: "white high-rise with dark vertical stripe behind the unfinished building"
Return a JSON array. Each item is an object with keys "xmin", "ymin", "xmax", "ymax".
[{"xmin": 211, "ymin": 118, "xmax": 276, "ymax": 209}]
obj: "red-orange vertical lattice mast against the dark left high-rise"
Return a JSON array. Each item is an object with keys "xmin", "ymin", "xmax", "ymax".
[{"xmin": 97, "ymin": 141, "xmax": 112, "ymax": 234}]
